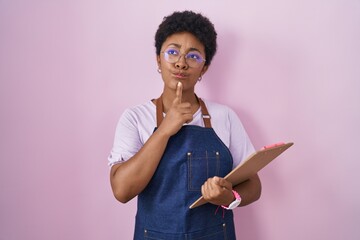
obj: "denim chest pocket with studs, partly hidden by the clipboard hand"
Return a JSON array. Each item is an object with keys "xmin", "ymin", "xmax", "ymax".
[{"xmin": 187, "ymin": 151, "xmax": 220, "ymax": 191}]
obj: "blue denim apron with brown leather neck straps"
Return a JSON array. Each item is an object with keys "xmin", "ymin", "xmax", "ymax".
[{"xmin": 134, "ymin": 97, "xmax": 236, "ymax": 240}]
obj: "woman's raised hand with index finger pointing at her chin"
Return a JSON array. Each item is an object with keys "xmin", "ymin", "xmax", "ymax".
[{"xmin": 159, "ymin": 82, "xmax": 193, "ymax": 136}]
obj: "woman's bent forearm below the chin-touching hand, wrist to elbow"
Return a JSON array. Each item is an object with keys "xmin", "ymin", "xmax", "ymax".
[{"xmin": 110, "ymin": 129, "xmax": 170, "ymax": 203}]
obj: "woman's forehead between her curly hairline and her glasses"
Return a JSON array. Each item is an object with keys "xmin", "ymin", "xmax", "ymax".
[{"xmin": 162, "ymin": 32, "xmax": 205, "ymax": 53}]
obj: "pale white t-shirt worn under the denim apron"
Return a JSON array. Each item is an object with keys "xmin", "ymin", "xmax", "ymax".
[{"xmin": 108, "ymin": 99, "xmax": 255, "ymax": 168}]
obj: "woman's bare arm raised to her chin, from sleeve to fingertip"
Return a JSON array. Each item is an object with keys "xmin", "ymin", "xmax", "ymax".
[{"xmin": 110, "ymin": 84, "xmax": 192, "ymax": 203}]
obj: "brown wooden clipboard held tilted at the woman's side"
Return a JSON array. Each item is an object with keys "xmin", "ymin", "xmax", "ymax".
[{"xmin": 189, "ymin": 142, "xmax": 294, "ymax": 209}]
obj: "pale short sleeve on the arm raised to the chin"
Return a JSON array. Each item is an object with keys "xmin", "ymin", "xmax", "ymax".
[{"xmin": 108, "ymin": 109, "xmax": 143, "ymax": 166}]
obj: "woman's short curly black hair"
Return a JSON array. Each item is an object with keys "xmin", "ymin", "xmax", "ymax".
[{"xmin": 155, "ymin": 11, "xmax": 217, "ymax": 65}]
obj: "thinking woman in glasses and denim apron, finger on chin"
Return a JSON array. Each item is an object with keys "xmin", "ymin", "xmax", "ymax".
[{"xmin": 109, "ymin": 11, "xmax": 261, "ymax": 240}]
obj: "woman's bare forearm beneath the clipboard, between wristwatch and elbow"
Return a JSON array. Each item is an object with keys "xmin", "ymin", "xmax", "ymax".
[{"xmin": 233, "ymin": 174, "xmax": 261, "ymax": 206}]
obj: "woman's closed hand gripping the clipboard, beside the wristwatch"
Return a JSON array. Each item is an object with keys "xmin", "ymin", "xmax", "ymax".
[{"xmin": 201, "ymin": 177, "xmax": 235, "ymax": 206}]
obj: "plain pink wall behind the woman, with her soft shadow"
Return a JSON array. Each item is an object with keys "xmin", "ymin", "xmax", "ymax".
[{"xmin": 0, "ymin": 0, "xmax": 360, "ymax": 240}]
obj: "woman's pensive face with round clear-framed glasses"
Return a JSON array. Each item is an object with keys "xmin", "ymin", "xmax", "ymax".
[{"xmin": 157, "ymin": 32, "xmax": 207, "ymax": 91}]
